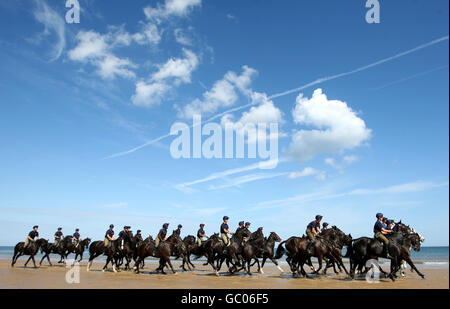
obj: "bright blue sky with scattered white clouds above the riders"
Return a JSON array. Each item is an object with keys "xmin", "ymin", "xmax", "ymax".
[{"xmin": 0, "ymin": 0, "xmax": 449, "ymax": 246}]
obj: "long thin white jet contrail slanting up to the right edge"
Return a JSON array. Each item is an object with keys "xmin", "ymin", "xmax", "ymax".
[{"xmin": 103, "ymin": 35, "xmax": 449, "ymax": 159}]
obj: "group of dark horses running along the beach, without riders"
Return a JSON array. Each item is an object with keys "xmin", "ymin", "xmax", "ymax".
[{"xmin": 12, "ymin": 221, "xmax": 424, "ymax": 281}]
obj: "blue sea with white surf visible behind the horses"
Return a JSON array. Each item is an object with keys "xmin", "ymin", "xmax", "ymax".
[{"xmin": 0, "ymin": 246, "xmax": 449, "ymax": 268}]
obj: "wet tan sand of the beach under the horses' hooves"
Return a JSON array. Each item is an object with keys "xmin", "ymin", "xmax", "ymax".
[{"xmin": 0, "ymin": 259, "xmax": 449, "ymax": 289}]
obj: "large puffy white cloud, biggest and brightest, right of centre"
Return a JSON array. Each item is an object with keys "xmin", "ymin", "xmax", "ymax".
[{"xmin": 288, "ymin": 89, "xmax": 371, "ymax": 161}]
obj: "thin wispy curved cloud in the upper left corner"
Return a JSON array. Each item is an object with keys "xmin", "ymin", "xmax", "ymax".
[{"xmin": 34, "ymin": 1, "xmax": 66, "ymax": 61}]
